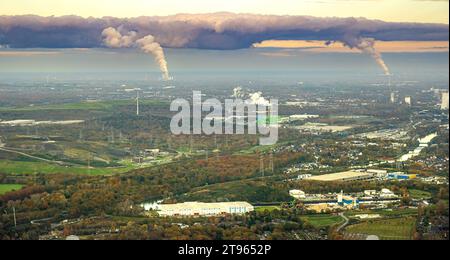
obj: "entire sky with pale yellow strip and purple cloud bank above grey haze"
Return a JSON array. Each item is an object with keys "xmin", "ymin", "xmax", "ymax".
[{"xmin": 0, "ymin": 0, "xmax": 449, "ymax": 54}]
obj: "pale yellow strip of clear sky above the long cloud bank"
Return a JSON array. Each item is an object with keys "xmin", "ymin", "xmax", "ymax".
[{"xmin": 0, "ymin": 0, "xmax": 449, "ymax": 24}]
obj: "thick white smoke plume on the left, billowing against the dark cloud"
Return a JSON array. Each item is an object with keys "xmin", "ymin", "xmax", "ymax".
[{"xmin": 102, "ymin": 27, "xmax": 171, "ymax": 80}]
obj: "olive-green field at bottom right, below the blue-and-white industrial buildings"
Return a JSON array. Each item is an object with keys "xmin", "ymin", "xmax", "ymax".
[{"xmin": 345, "ymin": 217, "xmax": 416, "ymax": 240}]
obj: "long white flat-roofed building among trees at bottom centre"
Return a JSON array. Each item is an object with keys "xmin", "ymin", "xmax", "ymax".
[{"xmin": 157, "ymin": 202, "xmax": 255, "ymax": 217}]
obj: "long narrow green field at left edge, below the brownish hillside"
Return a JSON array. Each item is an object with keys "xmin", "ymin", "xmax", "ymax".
[{"xmin": 0, "ymin": 160, "xmax": 132, "ymax": 175}]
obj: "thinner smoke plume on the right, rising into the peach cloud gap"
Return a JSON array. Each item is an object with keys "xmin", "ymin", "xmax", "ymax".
[{"xmin": 342, "ymin": 37, "xmax": 391, "ymax": 76}]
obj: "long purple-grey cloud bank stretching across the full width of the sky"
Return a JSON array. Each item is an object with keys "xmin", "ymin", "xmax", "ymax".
[{"xmin": 0, "ymin": 13, "xmax": 449, "ymax": 50}]
